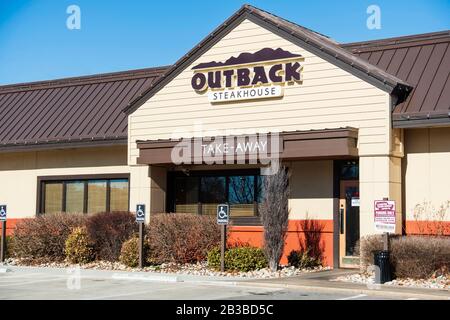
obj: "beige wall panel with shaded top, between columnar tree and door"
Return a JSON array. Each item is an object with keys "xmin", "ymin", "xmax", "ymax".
[{"xmin": 287, "ymin": 160, "xmax": 333, "ymax": 220}]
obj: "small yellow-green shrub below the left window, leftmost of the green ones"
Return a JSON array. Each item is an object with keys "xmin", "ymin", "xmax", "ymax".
[{"xmin": 65, "ymin": 226, "xmax": 94, "ymax": 263}]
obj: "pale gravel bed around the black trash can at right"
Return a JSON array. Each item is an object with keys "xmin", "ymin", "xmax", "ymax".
[{"xmin": 332, "ymin": 273, "xmax": 450, "ymax": 290}]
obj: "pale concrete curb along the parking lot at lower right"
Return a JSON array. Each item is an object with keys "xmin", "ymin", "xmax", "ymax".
[{"xmin": 235, "ymin": 282, "xmax": 450, "ymax": 300}]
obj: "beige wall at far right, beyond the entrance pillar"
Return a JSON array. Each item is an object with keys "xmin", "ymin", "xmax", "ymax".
[{"xmin": 403, "ymin": 127, "xmax": 450, "ymax": 221}]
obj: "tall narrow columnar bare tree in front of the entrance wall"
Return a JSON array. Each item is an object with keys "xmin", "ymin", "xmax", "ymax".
[{"xmin": 259, "ymin": 166, "xmax": 289, "ymax": 271}]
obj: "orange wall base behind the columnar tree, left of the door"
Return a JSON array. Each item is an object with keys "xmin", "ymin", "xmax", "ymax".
[{"xmin": 228, "ymin": 220, "xmax": 333, "ymax": 266}]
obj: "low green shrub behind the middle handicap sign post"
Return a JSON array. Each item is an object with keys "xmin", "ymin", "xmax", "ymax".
[{"xmin": 208, "ymin": 247, "xmax": 267, "ymax": 272}]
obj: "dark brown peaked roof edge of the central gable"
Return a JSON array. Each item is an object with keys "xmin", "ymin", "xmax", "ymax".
[{"xmin": 124, "ymin": 4, "xmax": 411, "ymax": 114}]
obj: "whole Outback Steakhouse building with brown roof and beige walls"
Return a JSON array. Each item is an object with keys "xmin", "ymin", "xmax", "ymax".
[{"xmin": 0, "ymin": 5, "xmax": 450, "ymax": 267}]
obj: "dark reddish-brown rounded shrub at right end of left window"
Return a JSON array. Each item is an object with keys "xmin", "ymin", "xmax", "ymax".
[{"xmin": 86, "ymin": 211, "xmax": 139, "ymax": 261}]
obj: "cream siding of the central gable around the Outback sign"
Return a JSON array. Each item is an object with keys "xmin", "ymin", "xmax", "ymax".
[{"xmin": 128, "ymin": 20, "xmax": 390, "ymax": 164}]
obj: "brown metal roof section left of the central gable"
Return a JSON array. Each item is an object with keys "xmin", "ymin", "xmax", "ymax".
[{"xmin": 0, "ymin": 67, "xmax": 167, "ymax": 150}]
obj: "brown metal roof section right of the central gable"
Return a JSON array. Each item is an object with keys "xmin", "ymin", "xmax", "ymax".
[{"xmin": 342, "ymin": 30, "xmax": 450, "ymax": 127}]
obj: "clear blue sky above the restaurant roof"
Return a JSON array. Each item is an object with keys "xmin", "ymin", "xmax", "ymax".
[{"xmin": 0, "ymin": 0, "xmax": 450, "ymax": 84}]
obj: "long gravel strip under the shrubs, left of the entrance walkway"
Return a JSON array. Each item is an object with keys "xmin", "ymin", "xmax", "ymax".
[{"xmin": 5, "ymin": 259, "xmax": 330, "ymax": 279}]
